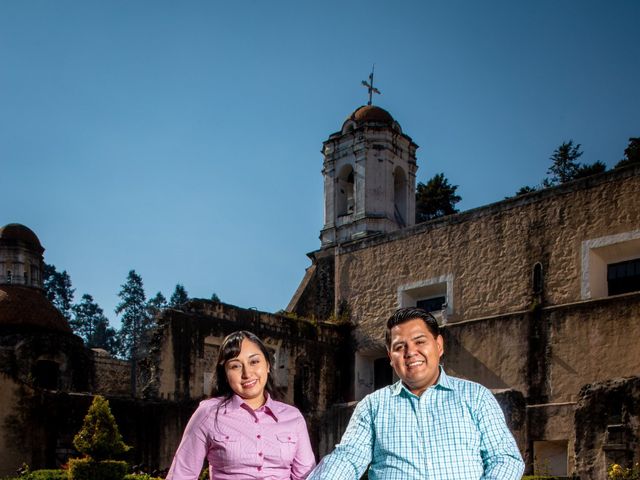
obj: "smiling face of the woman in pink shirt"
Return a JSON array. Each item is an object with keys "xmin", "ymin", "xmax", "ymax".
[{"xmin": 224, "ymin": 338, "xmax": 270, "ymax": 410}]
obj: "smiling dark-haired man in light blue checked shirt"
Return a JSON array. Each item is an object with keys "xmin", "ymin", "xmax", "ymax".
[{"xmin": 307, "ymin": 308, "xmax": 524, "ymax": 480}]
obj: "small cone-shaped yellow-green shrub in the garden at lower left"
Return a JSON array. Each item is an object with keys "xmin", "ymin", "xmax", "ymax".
[{"xmin": 73, "ymin": 395, "xmax": 131, "ymax": 462}]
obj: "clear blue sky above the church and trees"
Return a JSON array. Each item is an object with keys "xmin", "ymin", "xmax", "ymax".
[{"xmin": 0, "ymin": 0, "xmax": 640, "ymax": 325}]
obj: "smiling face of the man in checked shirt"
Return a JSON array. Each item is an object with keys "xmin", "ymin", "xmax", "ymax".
[{"xmin": 388, "ymin": 318, "xmax": 444, "ymax": 396}]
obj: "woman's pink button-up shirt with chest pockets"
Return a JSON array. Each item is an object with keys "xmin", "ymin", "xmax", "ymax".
[{"xmin": 167, "ymin": 395, "xmax": 316, "ymax": 480}]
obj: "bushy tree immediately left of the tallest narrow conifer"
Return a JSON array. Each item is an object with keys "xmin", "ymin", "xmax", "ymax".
[{"xmin": 69, "ymin": 293, "xmax": 116, "ymax": 353}]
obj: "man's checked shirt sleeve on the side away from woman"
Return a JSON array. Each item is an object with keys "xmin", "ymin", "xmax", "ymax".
[{"xmin": 476, "ymin": 389, "xmax": 524, "ymax": 480}]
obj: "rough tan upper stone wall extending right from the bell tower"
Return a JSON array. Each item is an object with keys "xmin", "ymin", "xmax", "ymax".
[{"xmin": 328, "ymin": 168, "xmax": 640, "ymax": 345}]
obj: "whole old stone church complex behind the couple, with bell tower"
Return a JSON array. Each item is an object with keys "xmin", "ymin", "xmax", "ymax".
[{"xmin": 0, "ymin": 105, "xmax": 640, "ymax": 480}]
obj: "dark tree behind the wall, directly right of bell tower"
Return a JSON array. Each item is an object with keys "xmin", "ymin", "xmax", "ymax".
[{"xmin": 416, "ymin": 173, "xmax": 462, "ymax": 223}]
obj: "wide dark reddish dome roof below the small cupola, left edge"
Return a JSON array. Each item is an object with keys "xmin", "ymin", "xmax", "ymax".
[{"xmin": 0, "ymin": 284, "xmax": 71, "ymax": 333}]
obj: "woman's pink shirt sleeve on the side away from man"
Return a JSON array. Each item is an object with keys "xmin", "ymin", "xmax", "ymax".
[{"xmin": 166, "ymin": 404, "xmax": 209, "ymax": 480}]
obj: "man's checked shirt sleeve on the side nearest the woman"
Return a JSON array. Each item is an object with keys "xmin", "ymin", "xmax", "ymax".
[{"xmin": 308, "ymin": 397, "xmax": 374, "ymax": 480}]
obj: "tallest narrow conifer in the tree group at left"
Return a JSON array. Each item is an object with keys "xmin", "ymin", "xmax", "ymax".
[{"xmin": 116, "ymin": 270, "xmax": 152, "ymax": 360}]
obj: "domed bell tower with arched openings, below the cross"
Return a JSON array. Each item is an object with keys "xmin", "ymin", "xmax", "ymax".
[{"xmin": 320, "ymin": 105, "xmax": 418, "ymax": 247}]
